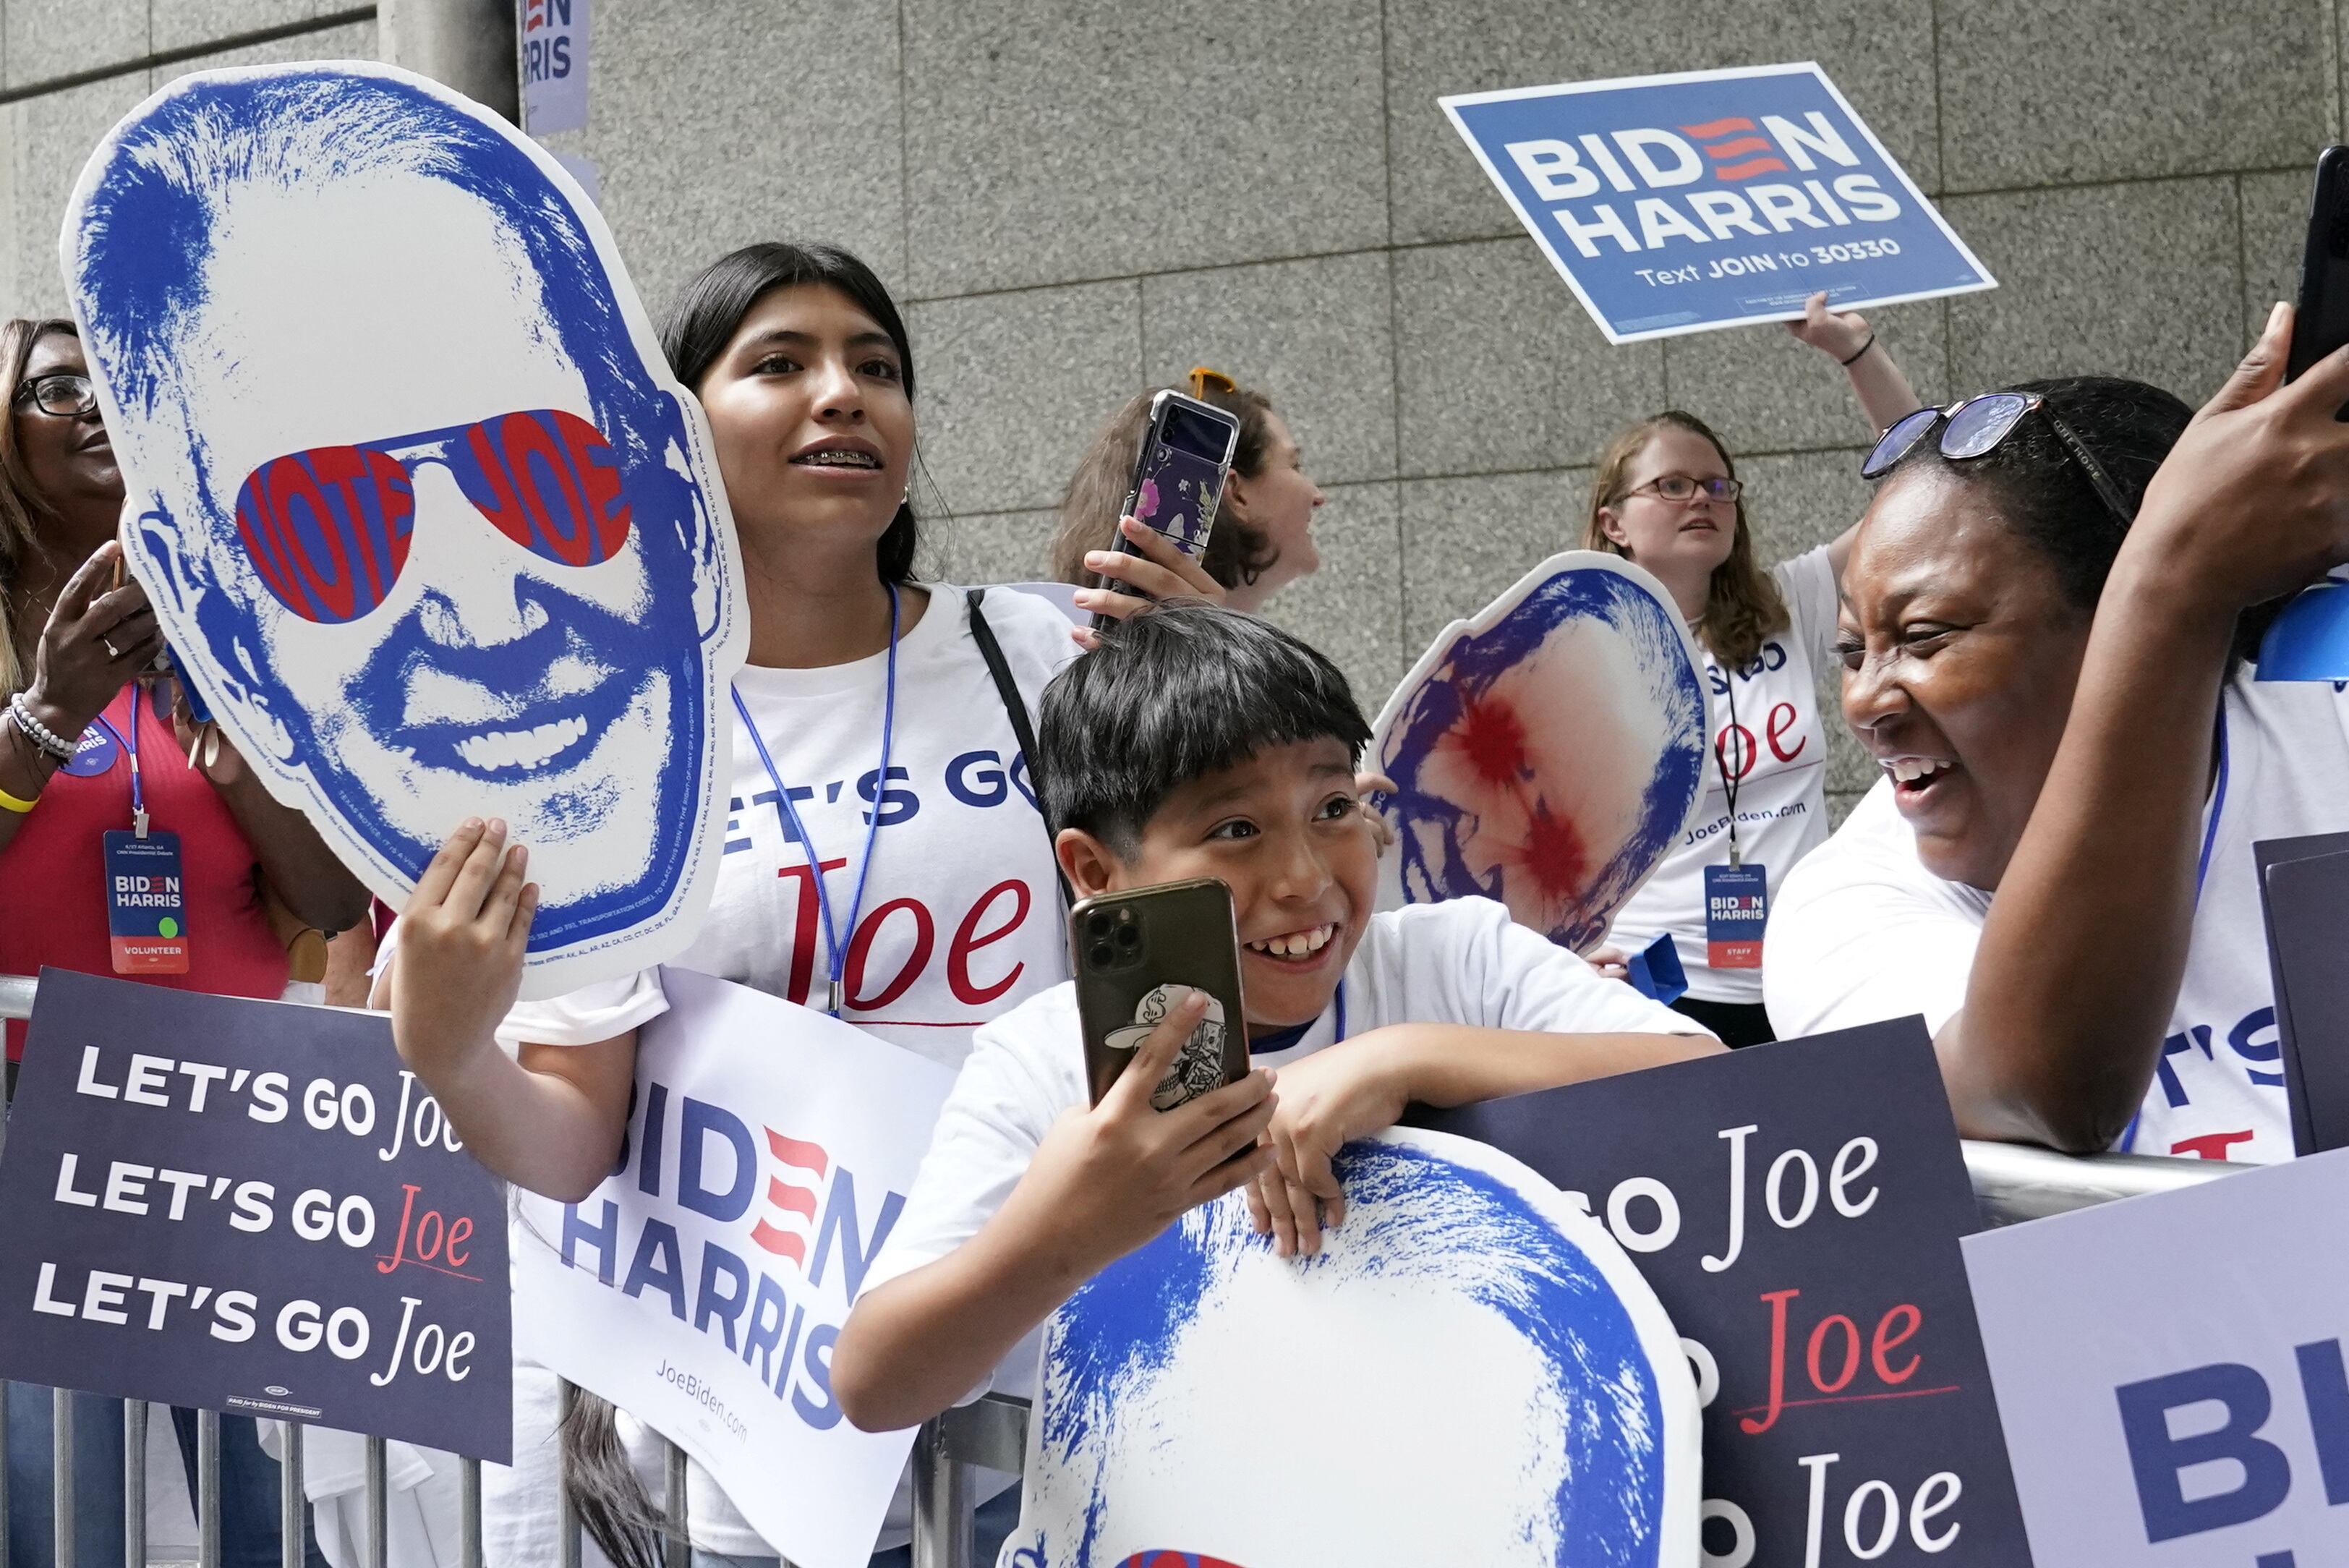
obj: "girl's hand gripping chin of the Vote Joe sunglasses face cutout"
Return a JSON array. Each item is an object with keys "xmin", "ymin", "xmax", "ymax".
[{"xmin": 392, "ymin": 820, "xmax": 538, "ymax": 1086}]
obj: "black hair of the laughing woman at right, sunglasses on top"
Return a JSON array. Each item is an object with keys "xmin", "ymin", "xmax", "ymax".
[{"xmin": 1893, "ymin": 376, "xmax": 2194, "ymax": 609}]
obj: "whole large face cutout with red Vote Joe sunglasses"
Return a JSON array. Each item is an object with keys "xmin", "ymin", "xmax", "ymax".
[{"xmin": 66, "ymin": 66, "xmax": 747, "ymax": 994}]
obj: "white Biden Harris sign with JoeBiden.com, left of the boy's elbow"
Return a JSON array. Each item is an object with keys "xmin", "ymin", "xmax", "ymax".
[{"xmin": 514, "ymin": 968, "xmax": 954, "ymax": 1568}]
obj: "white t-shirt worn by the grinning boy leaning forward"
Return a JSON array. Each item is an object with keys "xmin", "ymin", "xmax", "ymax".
[{"xmin": 864, "ymin": 898, "xmax": 1701, "ymax": 1363}]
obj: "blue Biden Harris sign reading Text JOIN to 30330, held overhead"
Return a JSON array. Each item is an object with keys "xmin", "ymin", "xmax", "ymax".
[{"xmin": 1442, "ymin": 64, "xmax": 1997, "ymax": 344}]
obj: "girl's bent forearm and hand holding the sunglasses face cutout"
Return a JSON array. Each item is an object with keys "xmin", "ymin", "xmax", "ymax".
[{"xmin": 376, "ymin": 820, "xmax": 636, "ymax": 1201}]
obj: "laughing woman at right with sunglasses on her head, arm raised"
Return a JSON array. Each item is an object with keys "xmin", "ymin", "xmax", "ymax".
[{"xmin": 1764, "ymin": 306, "xmax": 2349, "ymax": 1162}]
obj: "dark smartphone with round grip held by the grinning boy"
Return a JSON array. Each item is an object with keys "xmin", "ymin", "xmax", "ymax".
[{"xmin": 1069, "ymin": 877, "xmax": 1248, "ymax": 1109}]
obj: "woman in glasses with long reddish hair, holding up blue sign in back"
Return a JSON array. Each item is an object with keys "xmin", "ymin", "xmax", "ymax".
[{"xmin": 1583, "ymin": 294, "xmax": 1917, "ymax": 1046}]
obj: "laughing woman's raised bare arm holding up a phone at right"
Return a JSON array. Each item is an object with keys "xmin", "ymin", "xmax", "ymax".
[{"xmin": 1935, "ymin": 306, "xmax": 2349, "ymax": 1149}]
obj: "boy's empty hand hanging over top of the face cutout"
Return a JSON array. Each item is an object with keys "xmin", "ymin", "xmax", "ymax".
[{"xmin": 1248, "ymin": 1030, "xmax": 1410, "ymax": 1258}]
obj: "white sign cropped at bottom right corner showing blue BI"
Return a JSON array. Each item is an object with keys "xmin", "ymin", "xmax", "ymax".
[{"xmin": 1964, "ymin": 1149, "xmax": 2349, "ymax": 1568}]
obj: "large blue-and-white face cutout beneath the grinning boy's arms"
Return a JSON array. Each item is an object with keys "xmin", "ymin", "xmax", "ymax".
[{"xmin": 1010, "ymin": 1133, "xmax": 1698, "ymax": 1568}]
